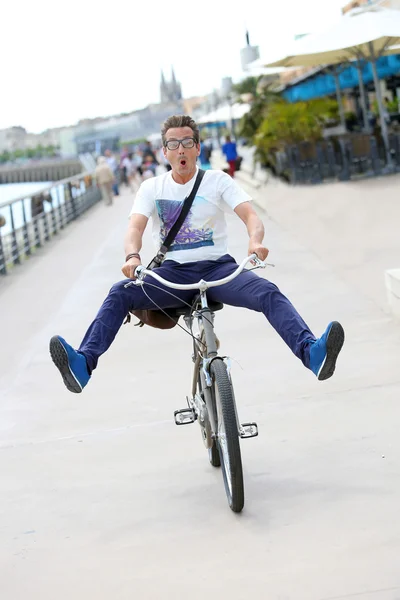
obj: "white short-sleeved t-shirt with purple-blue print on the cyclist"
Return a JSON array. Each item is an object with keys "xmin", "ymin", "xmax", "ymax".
[{"xmin": 130, "ymin": 169, "xmax": 251, "ymax": 263}]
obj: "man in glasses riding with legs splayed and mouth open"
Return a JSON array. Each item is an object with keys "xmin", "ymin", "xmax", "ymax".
[{"xmin": 50, "ymin": 115, "xmax": 344, "ymax": 393}]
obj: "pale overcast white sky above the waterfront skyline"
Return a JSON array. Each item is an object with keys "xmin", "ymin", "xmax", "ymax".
[{"xmin": 0, "ymin": 0, "xmax": 346, "ymax": 132}]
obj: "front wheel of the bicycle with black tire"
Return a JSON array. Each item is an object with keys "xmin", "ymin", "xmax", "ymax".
[{"xmin": 210, "ymin": 358, "xmax": 244, "ymax": 512}]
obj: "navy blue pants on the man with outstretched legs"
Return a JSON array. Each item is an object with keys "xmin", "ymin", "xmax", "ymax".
[{"xmin": 78, "ymin": 254, "xmax": 315, "ymax": 372}]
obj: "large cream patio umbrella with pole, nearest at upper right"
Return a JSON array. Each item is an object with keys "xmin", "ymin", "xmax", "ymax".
[{"xmin": 265, "ymin": 7, "xmax": 400, "ymax": 164}]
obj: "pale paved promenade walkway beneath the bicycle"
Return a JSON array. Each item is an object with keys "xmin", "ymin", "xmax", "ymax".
[{"xmin": 0, "ymin": 175, "xmax": 400, "ymax": 600}]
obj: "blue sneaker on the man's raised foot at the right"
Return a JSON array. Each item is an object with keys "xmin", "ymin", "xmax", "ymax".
[{"xmin": 310, "ymin": 321, "xmax": 344, "ymax": 381}]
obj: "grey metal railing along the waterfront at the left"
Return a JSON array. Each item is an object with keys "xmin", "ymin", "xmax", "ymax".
[{"xmin": 0, "ymin": 173, "xmax": 101, "ymax": 276}]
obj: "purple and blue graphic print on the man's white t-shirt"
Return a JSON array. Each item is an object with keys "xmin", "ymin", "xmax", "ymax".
[{"xmin": 156, "ymin": 196, "xmax": 214, "ymax": 252}]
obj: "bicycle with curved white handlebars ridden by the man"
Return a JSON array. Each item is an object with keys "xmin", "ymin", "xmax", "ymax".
[{"xmin": 126, "ymin": 254, "xmax": 266, "ymax": 513}]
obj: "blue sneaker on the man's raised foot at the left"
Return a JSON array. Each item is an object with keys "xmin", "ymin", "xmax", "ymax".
[{"xmin": 50, "ymin": 335, "xmax": 90, "ymax": 394}]
